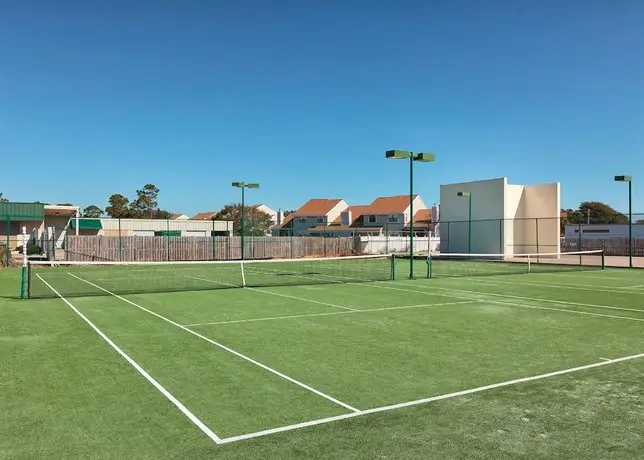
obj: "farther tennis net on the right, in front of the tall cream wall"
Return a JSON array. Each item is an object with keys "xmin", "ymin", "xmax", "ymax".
[{"xmin": 427, "ymin": 250, "xmax": 605, "ymax": 278}]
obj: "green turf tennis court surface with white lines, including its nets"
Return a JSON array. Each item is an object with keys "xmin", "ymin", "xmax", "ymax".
[{"xmin": 2, "ymin": 253, "xmax": 644, "ymax": 458}]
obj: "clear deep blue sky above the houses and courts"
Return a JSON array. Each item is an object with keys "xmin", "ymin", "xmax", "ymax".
[{"xmin": 0, "ymin": 0, "xmax": 644, "ymax": 214}]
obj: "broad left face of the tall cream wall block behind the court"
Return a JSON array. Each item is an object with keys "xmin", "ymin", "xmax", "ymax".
[{"xmin": 440, "ymin": 178, "xmax": 507, "ymax": 254}]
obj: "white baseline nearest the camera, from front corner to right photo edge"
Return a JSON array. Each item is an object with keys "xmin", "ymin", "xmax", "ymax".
[{"xmin": 221, "ymin": 353, "xmax": 644, "ymax": 444}]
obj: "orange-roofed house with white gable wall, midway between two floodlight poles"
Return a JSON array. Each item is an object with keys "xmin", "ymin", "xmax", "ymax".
[{"xmin": 273, "ymin": 198, "xmax": 349, "ymax": 236}]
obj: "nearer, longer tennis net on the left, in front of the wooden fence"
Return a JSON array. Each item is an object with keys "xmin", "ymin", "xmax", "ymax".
[{"xmin": 27, "ymin": 255, "xmax": 394, "ymax": 298}]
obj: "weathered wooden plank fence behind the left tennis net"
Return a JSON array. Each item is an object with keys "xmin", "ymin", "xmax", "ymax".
[{"xmin": 64, "ymin": 235, "xmax": 360, "ymax": 262}]
